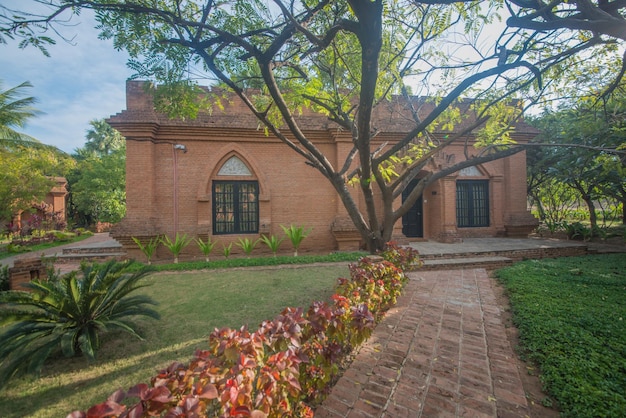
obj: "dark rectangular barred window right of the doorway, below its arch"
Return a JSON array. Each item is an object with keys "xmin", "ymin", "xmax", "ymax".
[{"xmin": 456, "ymin": 180, "xmax": 489, "ymax": 228}]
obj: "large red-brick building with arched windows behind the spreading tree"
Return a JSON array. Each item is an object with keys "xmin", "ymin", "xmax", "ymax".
[{"xmin": 108, "ymin": 81, "xmax": 537, "ymax": 258}]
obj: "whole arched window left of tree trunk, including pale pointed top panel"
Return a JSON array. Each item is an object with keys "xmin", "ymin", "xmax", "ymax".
[{"xmin": 212, "ymin": 156, "xmax": 259, "ymax": 235}]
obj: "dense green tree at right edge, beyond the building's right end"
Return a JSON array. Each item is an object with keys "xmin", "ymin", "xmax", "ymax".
[{"xmin": 529, "ymin": 89, "xmax": 626, "ymax": 225}]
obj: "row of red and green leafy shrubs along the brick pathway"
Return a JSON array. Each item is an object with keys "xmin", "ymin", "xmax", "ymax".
[{"xmin": 68, "ymin": 245, "xmax": 418, "ymax": 418}]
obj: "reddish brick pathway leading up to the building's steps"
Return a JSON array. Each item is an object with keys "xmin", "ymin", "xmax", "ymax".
[{"xmin": 315, "ymin": 269, "xmax": 529, "ymax": 418}]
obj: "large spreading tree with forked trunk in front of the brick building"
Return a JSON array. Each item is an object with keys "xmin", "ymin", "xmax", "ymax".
[{"xmin": 0, "ymin": 0, "xmax": 626, "ymax": 250}]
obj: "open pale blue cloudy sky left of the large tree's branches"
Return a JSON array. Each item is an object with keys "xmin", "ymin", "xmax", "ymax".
[{"xmin": 0, "ymin": 0, "xmax": 133, "ymax": 153}]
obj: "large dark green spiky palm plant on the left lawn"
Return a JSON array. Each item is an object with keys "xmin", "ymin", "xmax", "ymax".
[{"xmin": 0, "ymin": 260, "xmax": 159, "ymax": 387}]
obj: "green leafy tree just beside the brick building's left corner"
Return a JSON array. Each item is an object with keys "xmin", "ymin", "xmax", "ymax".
[{"xmin": 68, "ymin": 119, "xmax": 126, "ymax": 227}]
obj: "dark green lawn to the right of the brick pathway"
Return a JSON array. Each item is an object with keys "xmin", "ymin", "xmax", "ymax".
[{"xmin": 498, "ymin": 254, "xmax": 626, "ymax": 417}]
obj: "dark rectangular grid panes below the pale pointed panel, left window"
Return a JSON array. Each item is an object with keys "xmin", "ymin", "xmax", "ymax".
[{"xmin": 213, "ymin": 181, "xmax": 259, "ymax": 235}]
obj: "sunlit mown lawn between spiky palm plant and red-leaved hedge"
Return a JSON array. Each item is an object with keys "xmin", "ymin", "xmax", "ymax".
[{"xmin": 0, "ymin": 263, "xmax": 348, "ymax": 418}]
